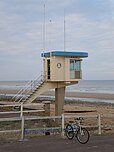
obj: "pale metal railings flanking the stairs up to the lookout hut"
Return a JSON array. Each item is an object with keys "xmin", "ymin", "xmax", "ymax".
[{"xmin": 12, "ymin": 75, "xmax": 44, "ymax": 103}]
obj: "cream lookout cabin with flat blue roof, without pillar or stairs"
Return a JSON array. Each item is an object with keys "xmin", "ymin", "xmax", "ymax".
[{"xmin": 42, "ymin": 51, "xmax": 88, "ymax": 84}]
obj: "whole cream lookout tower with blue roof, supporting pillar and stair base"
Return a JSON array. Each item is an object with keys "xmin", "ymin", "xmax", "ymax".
[{"xmin": 15, "ymin": 51, "xmax": 88, "ymax": 115}]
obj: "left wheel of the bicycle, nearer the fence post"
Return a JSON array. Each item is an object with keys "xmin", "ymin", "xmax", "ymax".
[{"xmin": 65, "ymin": 124, "xmax": 74, "ymax": 140}]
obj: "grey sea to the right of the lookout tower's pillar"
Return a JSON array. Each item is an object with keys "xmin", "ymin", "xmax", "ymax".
[{"xmin": 67, "ymin": 80, "xmax": 114, "ymax": 104}]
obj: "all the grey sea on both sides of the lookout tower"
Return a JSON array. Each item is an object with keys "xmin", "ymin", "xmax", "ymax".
[{"xmin": 0, "ymin": 80, "xmax": 114, "ymax": 104}]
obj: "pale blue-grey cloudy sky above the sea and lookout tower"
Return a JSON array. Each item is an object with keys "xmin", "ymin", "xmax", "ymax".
[{"xmin": 0, "ymin": 0, "xmax": 114, "ymax": 81}]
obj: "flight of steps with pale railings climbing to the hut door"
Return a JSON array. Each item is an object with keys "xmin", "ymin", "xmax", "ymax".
[{"xmin": 12, "ymin": 75, "xmax": 45, "ymax": 103}]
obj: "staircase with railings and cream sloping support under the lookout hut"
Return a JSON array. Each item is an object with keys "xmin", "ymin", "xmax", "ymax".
[{"xmin": 12, "ymin": 75, "xmax": 70, "ymax": 103}]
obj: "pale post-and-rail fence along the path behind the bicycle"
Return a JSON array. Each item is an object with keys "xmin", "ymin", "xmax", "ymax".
[{"xmin": 0, "ymin": 108, "xmax": 114, "ymax": 140}]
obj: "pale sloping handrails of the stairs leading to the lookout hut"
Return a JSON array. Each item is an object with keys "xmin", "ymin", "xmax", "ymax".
[{"xmin": 12, "ymin": 74, "xmax": 44, "ymax": 102}]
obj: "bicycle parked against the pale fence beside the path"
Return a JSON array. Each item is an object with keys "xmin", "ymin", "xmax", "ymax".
[{"xmin": 65, "ymin": 117, "xmax": 90, "ymax": 144}]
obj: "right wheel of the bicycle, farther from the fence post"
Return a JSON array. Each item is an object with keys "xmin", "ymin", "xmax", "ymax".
[{"xmin": 76, "ymin": 128, "xmax": 90, "ymax": 144}]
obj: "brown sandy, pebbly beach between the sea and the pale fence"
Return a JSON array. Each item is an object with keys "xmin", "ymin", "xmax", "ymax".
[{"xmin": 0, "ymin": 90, "xmax": 114, "ymax": 133}]
